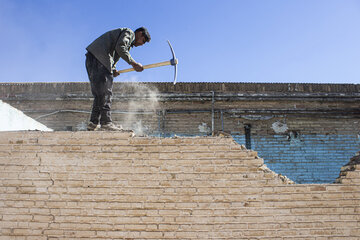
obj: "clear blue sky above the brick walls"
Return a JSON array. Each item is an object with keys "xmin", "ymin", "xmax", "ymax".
[{"xmin": 0, "ymin": 0, "xmax": 360, "ymax": 83}]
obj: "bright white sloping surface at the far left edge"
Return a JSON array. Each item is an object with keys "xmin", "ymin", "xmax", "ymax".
[{"xmin": 0, "ymin": 100, "xmax": 53, "ymax": 131}]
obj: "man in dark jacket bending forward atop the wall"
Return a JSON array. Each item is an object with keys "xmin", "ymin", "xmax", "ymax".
[{"xmin": 86, "ymin": 27, "xmax": 151, "ymax": 131}]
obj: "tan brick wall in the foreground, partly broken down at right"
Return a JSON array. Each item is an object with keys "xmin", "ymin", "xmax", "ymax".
[{"xmin": 0, "ymin": 131, "xmax": 360, "ymax": 240}]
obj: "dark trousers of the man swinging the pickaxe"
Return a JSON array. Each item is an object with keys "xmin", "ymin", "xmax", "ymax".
[{"xmin": 85, "ymin": 52, "xmax": 114, "ymax": 125}]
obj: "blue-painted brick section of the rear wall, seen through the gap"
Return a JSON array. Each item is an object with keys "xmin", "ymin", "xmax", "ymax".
[{"xmin": 233, "ymin": 134, "xmax": 360, "ymax": 183}]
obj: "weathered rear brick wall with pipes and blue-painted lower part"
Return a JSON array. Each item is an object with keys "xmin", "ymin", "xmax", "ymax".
[{"xmin": 0, "ymin": 83, "xmax": 360, "ymax": 183}]
